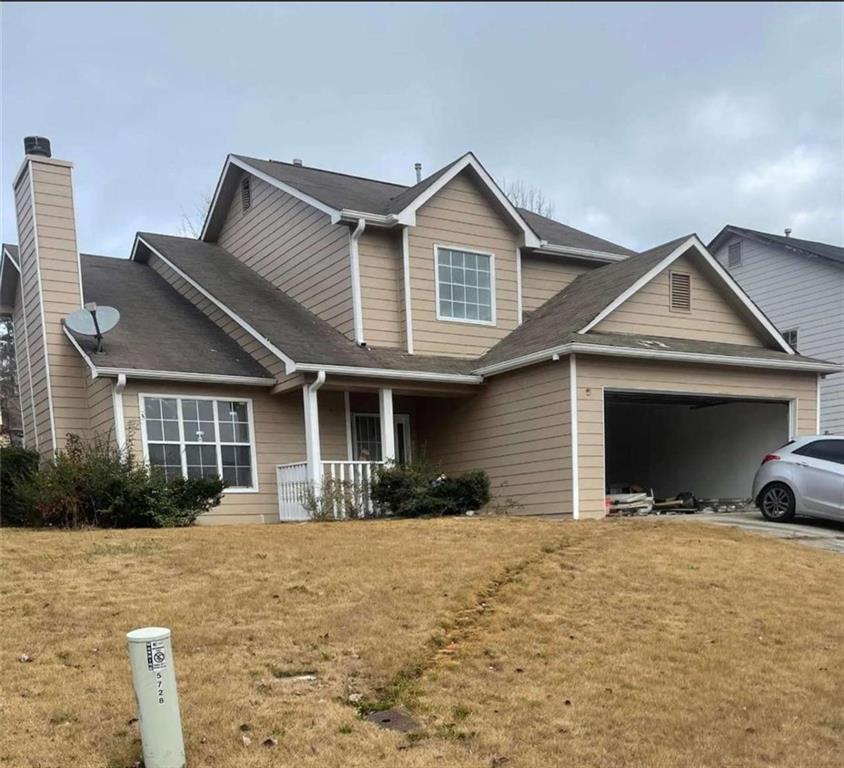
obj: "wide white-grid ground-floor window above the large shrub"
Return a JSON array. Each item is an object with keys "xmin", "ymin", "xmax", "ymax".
[{"xmin": 142, "ymin": 396, "xmax": 255, "ymax": 490}]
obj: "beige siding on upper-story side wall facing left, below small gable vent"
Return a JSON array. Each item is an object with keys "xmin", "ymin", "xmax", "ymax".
[{"xmin": 217, "ymin": 176, "xmax": 354, "ymax": 338}]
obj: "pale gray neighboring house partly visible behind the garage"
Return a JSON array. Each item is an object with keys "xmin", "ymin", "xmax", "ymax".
[{"xmin": 709, "ymin": 225, "xmax": 844, "ymax": 435}]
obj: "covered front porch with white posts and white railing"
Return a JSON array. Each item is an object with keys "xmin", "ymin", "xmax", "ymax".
[{"xmin": 276, "ymin": 373, "xmax": 478, "ymax": 522}]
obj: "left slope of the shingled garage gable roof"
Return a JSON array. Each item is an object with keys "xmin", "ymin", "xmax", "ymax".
[{"xmin": 481, "ymin": 235, "xmax": 691, "ymax": 365}]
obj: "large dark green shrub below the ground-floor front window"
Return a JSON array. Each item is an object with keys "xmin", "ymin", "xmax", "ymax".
[{"xmin": 18, "ymin": 435, "xmax": 225, "ymax": 528}]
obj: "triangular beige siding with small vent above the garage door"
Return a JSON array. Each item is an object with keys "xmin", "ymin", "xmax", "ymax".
[{"xmin": 594, "ymin": 256, "xmax": 766, "ymax": 347}]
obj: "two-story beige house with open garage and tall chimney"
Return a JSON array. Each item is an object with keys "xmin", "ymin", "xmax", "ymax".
[{"xmin": 0, "ymin": 139, "xmax": 839, "ymax": 523}]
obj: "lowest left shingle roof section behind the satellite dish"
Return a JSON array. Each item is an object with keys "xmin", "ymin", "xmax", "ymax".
[{"xmin": 74, "ymin": 254, "xmax": 272, "ymax": 379}]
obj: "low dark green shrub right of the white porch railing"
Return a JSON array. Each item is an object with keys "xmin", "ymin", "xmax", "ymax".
[{"xmin": 372, "ymin": 461, "xmax": 490, "ymax": 517}]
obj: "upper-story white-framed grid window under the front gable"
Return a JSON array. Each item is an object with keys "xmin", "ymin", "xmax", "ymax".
[{"xmin": 434, "ymin": 245, "xmax": 495, "ymax": 325}]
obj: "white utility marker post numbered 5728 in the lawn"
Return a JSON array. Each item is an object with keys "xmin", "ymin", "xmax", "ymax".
[{"xmin": 126, "ymin": 627, "xmax": 185, "ymax": 768}]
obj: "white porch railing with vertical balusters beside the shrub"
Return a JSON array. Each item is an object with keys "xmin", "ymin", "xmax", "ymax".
[{"xmin": 276, "ymin": 461, "xmax": 382, "ymax": 522}]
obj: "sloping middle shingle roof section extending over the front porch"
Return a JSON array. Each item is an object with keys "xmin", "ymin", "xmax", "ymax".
[{"xmin": 139, "ymin": 232, "xmax": 482, "ymax": 373}]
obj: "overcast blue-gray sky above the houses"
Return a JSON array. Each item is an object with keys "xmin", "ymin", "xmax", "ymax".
[{"xmin": 0, "ymin": 3, "xmax": 844, "ymax": 256}]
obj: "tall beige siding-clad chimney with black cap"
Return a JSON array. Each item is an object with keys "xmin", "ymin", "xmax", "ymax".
[{"xmin": 14, "ymin": 136, "xmax": 88, "ymax": 456}]
